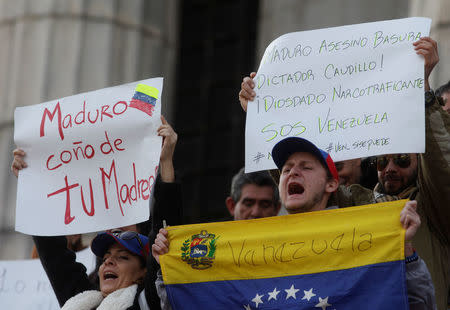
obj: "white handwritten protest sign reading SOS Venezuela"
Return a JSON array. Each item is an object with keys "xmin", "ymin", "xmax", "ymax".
[{"xmin": 245, "ymin": 18, "xmax": 431, "ymax": 172}]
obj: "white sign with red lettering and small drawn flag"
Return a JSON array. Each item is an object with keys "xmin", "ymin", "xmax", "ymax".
[{"xmin": 14, "ymin": 78, "xmax": 163, "ymax": 236}]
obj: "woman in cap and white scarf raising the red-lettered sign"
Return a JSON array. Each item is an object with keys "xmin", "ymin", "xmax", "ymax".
[{"xmin": 11, "ymin": 117, "xmax": 182, "ymax": 310}]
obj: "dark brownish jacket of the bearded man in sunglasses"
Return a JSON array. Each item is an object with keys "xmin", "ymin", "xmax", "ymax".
[{"xmin": 333, "ymin": 101, "xmax": 450, "ymax": 310}]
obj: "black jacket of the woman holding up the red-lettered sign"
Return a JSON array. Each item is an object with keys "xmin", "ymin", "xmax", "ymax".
[{"xmin": 33, "ymin": 179, "xmax": 182, "ymax": 310}]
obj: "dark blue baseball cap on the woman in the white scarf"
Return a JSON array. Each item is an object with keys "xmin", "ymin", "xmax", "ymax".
[{"xmin": 91, "ymin": 231, "xmax": 150, "ymax": 258}]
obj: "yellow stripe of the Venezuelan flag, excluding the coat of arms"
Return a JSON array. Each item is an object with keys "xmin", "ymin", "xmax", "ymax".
[{"xmin": 161, "ymin": 200, "xmax": 406, "ymax": 284}]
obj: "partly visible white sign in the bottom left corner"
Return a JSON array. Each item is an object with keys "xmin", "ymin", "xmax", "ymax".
[{"xmin": 0, "ymin": 248, "xmax": 95, "ymax": 310}]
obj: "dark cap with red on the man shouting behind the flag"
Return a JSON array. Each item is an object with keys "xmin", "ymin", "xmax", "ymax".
[{"xmin": 272, "ymin": 137, "xmax": 339, "ymax": 181}]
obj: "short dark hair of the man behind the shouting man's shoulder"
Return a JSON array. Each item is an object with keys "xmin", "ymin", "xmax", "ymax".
[{"xmin": 230, "ymin": 168, "xmax": 280, "ymax": 206}]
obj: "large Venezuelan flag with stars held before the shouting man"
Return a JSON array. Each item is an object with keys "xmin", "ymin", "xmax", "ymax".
[{"xmin": 161, "ymin": 200, "xmax": 408, "ymax": 310}]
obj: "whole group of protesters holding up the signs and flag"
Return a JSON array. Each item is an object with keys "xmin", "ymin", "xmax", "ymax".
[{"xmin": 12, "ymin": 34, "xmax": 450, "ymax": 310}]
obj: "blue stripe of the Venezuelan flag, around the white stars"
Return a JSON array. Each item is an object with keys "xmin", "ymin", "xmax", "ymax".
[{"xmin": 167, "ymin": 261, "xmax": 408, "ymax": 310}]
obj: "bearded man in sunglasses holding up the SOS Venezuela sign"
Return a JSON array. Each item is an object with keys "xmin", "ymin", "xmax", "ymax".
[{"xmin": 239, "ymin": 37, "xmax": 450, "ymax": 310}]
